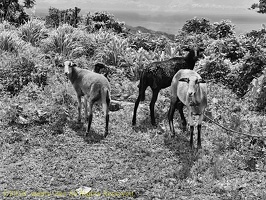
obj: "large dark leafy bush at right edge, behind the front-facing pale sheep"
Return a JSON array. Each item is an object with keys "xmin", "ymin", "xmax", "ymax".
[{"xmin": 201, "ymin": 37, "xmax": 265, "ymax": 97}]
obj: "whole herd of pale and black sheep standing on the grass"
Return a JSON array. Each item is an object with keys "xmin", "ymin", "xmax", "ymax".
[{"xmin": 64, "ymin": 48, "xmax": 207, "ymax": 148}]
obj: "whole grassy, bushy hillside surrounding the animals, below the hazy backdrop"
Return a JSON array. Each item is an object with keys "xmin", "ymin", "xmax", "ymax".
[{"xmin": 0, "ymin": 19, "xmax": 266, "ymax": 200}]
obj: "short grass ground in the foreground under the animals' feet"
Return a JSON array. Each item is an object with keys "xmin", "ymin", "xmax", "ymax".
[{"xmin": 0, "ymin": 79, "xmax": 266, "ymax": 199}]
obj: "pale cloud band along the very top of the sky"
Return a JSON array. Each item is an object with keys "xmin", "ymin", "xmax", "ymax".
[{"xmin": 36, "ymin": 0, "xmax": 256, "ymax": 13}]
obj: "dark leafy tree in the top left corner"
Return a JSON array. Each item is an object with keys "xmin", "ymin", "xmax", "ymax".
[{"xmin": 0, "ymin": 0, "xmax": 36, "ymax": 24}]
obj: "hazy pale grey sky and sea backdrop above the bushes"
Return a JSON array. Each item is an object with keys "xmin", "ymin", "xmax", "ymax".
[{"xmin": 35, "ymin": 0, "xmax": 266, "ymax": 34}]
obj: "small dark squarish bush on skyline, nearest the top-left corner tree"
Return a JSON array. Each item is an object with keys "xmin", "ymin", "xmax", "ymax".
[{"xmin": 45, "ymin": 7, "xmax": 81, "ymax": 28}]
